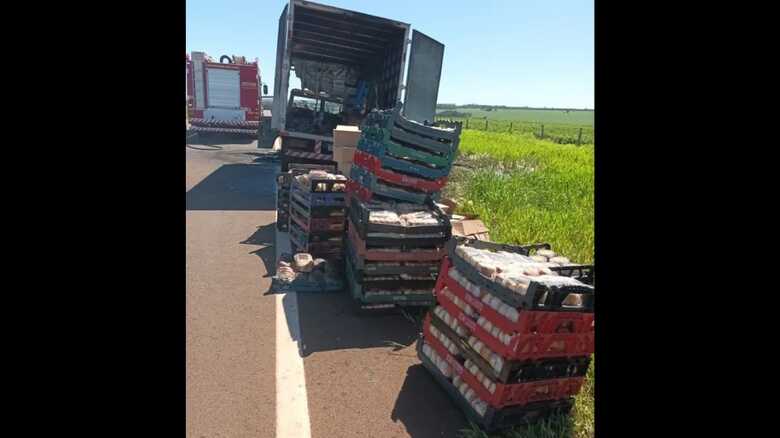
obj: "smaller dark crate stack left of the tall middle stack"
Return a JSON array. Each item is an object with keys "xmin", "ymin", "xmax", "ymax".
[{"xmin": 290, "ymin": 170, "xmax": 347, "ymax": 260}]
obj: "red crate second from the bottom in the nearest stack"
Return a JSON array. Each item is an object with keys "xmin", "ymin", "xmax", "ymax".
[{"xmin": 423, "ymin": 314, "xmax": 585, "ymax": 408}]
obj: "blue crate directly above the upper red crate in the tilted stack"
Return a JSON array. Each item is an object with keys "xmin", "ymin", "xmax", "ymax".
[{"xmin": 357, "ymin": 135, "xmax": 455, "ymax": 169}]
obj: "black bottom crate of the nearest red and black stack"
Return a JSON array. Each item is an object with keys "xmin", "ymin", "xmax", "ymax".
[{"xmin": 417, "ymin": 337, "xmax": 574, "ymax": 432}]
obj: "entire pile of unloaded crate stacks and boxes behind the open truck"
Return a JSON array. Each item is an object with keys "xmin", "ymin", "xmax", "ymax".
[{"xmin": 277, "ymin": 103, "xmax": 595, "ymax": 431}]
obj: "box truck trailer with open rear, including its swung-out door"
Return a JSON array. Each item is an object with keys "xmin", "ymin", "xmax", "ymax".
[{"xmin": 271, "ymin": 0, "xmax": 444, "ymax": 171}]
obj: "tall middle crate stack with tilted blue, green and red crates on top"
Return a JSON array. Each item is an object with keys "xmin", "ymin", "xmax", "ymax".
[{"xmin": 346, "ymin": 106, "xmax": 461, "ymax": 309}]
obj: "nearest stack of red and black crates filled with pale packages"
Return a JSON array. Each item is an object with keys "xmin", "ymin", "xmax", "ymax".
[{"xmin": 418, "ymin": 237, "xmax": 594, "ymax": 430}]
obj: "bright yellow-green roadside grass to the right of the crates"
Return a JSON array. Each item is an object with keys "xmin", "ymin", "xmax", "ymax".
[{"xmin": 444, "ymin": 129, "xmax": 595, "ymax": 438}]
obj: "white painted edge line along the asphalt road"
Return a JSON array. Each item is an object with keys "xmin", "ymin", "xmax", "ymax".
[{"xmin": 274, "ymin": 192, "xmax": 311, "ymax": 438}]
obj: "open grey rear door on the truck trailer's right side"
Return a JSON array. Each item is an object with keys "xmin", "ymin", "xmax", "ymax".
[{"xmin": 403, "ymin": 30, "xmax": 444, "ymax": 122}]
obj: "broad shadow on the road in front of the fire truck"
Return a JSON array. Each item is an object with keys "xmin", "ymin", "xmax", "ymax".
[{"xmin": 187, "ymin": 162, "xmax": 279, "ymax": 210}]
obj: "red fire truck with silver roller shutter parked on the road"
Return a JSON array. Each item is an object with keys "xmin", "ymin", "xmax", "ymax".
[{"xmin": 187, "ymin": 52, "xmax": 267, "ymax": 137}]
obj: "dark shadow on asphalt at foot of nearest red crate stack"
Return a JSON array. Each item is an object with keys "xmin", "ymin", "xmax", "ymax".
[{"xmin": 390, "ymin": 364, "xmax": 469, "ymax": 438}]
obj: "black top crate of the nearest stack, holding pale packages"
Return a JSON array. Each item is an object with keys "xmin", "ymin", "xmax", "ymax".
[{"xmin": 447, "ymin": 237, "xmax": 595, "ymax": 311}]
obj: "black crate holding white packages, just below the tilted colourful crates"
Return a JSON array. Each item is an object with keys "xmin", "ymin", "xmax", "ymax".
[{"xmin": 349, "ymin": 197, "xmax": 452, "ymax": 240}]
